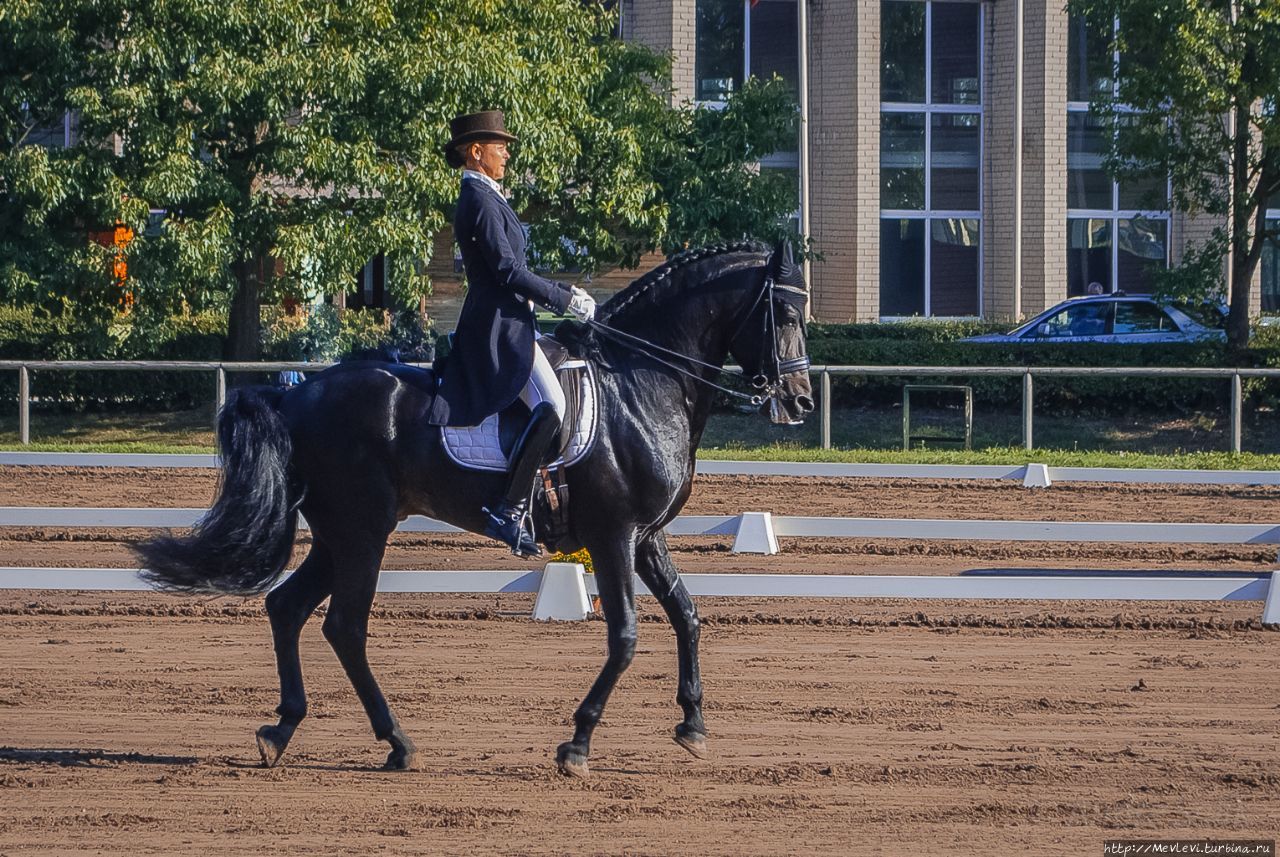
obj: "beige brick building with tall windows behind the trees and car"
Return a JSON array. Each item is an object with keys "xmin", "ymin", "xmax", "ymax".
[{"xmin": 622, "ymin": 0, "xmax": 1280, "ymax": 321}]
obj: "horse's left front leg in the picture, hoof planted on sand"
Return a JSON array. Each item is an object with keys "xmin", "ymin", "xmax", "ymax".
[{"xmin": 556, "ymin": 539, "xmax": 636, "ymax": 776}]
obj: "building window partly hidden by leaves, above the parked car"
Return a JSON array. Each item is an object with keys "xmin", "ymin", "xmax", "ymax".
[{"xmin": 1066, "ymin": 17, "xmax": 1169, "ymax": 297}]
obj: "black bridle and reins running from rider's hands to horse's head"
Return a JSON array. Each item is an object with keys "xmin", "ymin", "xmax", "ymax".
[{"xmin": 586, "ymin": 258, "xmax": 810, "ymax": 405}]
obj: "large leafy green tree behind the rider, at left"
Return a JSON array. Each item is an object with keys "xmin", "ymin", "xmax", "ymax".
[{"xmin": 0, "ymin": 0, "xmax": 794, "ymax": 359}]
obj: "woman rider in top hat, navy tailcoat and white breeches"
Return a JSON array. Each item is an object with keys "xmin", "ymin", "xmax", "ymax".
[{"xmin": 430, "ymin": 110, "xmax": 595, "ymax": 556}]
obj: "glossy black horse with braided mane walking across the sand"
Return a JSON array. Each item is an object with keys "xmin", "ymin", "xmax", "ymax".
[{"xmin": 137, "ymin": 243, "xmax": 813, "ymax": 776}]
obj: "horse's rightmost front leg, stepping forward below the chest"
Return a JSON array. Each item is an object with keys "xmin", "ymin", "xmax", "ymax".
[{"xmin": 636, "ymin": 532, "xmax": 707, "ymax": 759}]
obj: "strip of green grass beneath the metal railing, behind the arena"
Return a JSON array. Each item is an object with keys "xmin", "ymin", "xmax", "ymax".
[{"xmin": 0, "ymin": 405, "xmax": 1280, "ymax": 469}]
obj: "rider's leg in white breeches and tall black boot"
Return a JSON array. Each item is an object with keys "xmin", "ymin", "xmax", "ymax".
[{"xmin": 485, "ymin": 347, "xmax": 564, "ymax": 556}]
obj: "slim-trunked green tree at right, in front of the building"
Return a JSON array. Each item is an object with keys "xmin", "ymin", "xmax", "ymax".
[{"xmin": 1069, "ymin": 0, "xmax": 1280, "ymax": 348}]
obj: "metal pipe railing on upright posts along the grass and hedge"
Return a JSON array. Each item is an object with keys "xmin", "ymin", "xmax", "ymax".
[{"xmin": 0, "ymin": 361, "xmax": 1280, "ymax": 453}]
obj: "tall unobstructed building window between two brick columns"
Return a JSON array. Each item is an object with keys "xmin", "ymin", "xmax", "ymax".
[{"xmin": 881, "ymin": 0, "xmax": 983, "ymax": 317}]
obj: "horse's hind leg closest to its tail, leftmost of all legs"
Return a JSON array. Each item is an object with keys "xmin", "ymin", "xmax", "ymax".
[{"xmin": 257, "ymin": 541, "xmax": 333, "ymax": 767}]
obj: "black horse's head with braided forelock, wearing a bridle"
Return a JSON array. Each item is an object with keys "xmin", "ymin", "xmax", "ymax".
[{"xmin": 730, "ymin": 242, "xmax": 813, "ymax": 426}]
